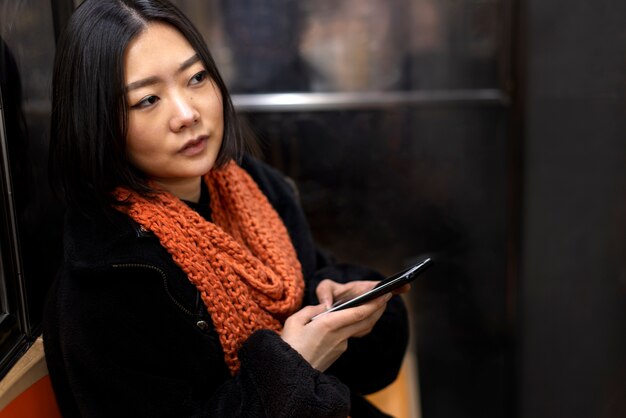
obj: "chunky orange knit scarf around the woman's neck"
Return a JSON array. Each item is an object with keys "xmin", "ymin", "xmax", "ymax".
[{"xmin": 115, "ymin": 162, "xmax": 304, "ymax": 374}]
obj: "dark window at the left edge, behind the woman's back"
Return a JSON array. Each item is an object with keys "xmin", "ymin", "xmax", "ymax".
[{"xmin": 0, "ymin": 0, "xmax": 62, "ymax": 374}]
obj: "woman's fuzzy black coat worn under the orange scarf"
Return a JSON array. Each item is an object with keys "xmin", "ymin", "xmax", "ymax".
[{"xmin": 44, "ymin": 158, "xmax": 408, "ymax": 418}]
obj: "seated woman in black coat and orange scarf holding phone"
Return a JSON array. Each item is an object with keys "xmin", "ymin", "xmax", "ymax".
[{"xmin": 44, "ymin": 0, "xmax": 407, "ymax": 417}]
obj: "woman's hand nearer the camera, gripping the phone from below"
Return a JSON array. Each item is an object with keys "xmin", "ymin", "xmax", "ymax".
[{"xmin": 281, "ymin": 294, "xmax": 392, "ymax": 372}]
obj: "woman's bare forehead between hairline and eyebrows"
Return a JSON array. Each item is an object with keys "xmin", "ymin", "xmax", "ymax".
[{"xmin": 124, "ymin": 22, "xmax": 195, "ymax": 82}]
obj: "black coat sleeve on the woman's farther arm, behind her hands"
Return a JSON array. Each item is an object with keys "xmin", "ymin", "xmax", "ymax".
[{"xmin": 244, "ymin": 159, "xmax": 409, "ymax": 394}]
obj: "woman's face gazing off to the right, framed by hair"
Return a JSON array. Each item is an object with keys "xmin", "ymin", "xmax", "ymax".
[{"xmin": 124, "ymin": 23, "xmax": 224, "ymax": 198}]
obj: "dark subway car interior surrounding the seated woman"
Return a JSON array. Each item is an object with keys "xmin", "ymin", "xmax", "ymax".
[{"xmin": 0, "ymin": 0, "xmax": 626, "ymax": 418}]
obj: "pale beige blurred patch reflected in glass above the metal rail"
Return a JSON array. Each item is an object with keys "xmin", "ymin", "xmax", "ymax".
[{"xmin": 300, "ymin": 0, "xmax": 406, "ymax": 91}]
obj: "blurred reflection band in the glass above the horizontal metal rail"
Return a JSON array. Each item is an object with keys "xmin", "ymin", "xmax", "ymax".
[{"xmin": 176, "ymin": 0, "xmax": 506, "ymax": 93}]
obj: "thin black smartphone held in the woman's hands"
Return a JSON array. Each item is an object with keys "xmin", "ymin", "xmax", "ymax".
[{"xmin": 311, "ymin": 257, "xmax": 433, "ymax": 321}]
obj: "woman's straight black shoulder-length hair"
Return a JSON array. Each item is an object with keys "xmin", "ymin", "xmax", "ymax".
[{"xmin": 49, "ymin": 0, "xmax": 246, "ymax": 209}]
